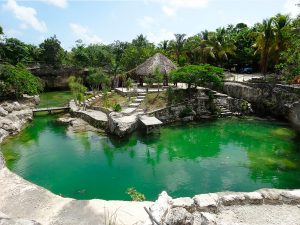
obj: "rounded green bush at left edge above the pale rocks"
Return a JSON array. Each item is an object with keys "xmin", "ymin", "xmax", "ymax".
[{"xmin": 0, "ymin": 65, "xmax": 43, "ymax": 98}]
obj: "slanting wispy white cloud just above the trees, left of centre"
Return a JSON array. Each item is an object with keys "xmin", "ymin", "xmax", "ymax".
[{"xmin": 70, "ymin": 23, "xmax": 104, "ymax": 44}]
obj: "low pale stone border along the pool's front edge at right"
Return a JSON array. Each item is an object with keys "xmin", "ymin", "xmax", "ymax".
[{"xmin": 144, "ymin": 189, "xmax": 300, "ymax": 225}]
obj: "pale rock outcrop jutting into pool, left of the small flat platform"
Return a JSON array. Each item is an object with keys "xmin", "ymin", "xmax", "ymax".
[{"xmin": 108, "ymin": 112, "xmax": 138, "ymax": 137}]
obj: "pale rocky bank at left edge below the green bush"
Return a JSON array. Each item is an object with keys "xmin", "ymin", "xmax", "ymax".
[{"xmin": 0, "ymin": 96, "xmax": 39, "ymax": 142}]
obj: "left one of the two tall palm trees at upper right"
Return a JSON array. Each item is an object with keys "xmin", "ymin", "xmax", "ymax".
[{"xmin": 254, "ymin": 18, "xmax": 275, "ymax": 75}]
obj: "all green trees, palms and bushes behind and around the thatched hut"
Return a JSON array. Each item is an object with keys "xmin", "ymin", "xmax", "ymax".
[{"xmin": 0, "ymin": 10, "xmax": 300, "ymax": 99}]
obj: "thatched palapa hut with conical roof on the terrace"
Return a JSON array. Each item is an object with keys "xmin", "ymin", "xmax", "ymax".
[{"xmin": 128, "ymin": 53, "xmax": 177, "ymax": 86}]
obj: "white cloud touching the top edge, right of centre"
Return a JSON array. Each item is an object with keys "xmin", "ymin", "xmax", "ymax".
[{"xmin": 149, "ymin": 0, "xmax": 210, "ymax": 16}]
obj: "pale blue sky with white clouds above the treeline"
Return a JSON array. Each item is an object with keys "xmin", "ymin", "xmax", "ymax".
[{"xmin": 0, "ymin": 0, "xmax": 300, "ymax": 49}]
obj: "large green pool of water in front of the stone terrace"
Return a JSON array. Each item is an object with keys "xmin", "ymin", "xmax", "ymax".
[{"xmin": 1, "ymin": 116, "xmax": 300, "ymax": 200}]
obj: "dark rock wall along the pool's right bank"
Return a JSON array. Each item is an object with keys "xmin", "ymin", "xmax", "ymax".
[{"xmin": 221, "ymin": 82, "xmax": 300, "ymax": 128}]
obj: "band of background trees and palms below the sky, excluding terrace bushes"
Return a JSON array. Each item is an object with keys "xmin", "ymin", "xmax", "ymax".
[{"xmin": 0, "ymin": 10, "xmax": 299, "ymax": 86}]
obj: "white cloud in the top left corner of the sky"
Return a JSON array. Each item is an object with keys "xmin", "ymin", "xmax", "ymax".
[{"xmin": 3, "ymin": 0, "xmax": 47, "ymax": 32}]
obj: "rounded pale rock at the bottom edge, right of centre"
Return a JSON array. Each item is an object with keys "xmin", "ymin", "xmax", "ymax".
[{"xmin": 165, "ymin": 207, "xmax": 193, "ymax": 225}]
